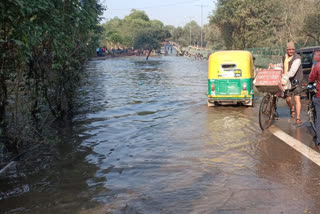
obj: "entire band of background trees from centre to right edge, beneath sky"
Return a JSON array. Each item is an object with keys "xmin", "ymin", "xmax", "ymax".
[{"xmin": 101, "ymin": 0, "xmax": 320, "ymax": 56}]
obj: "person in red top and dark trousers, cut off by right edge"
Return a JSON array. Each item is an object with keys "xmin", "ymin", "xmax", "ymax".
[{"xmin": 309, "ymin": 50, "xmax": 320, "ymax": 146}]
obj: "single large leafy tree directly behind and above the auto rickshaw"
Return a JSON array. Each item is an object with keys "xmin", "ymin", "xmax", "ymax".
[{"xmin": 210, "ymin": 0, "xmax": 283, "ymax": 49}]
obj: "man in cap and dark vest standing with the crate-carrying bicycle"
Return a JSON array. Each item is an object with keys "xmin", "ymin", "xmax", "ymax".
[{"xmin": 269, "ymin": 41, "xmax": 303, "ymax": 124}]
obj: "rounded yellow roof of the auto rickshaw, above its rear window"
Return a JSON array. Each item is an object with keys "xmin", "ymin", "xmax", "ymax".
[{"xmin": 209, "ymin": 50, "xmax": 252, "ymax": 61}]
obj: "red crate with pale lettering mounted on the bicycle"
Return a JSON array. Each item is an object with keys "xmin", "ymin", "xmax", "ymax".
[{"xmin": 255, "ymin": 69, "xmax": 283, "ymax": 93}]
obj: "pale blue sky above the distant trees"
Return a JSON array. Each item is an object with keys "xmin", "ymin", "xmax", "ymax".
[{"xmin": 101, "ymin": 0, "xmax": 215, "ymax": 27}]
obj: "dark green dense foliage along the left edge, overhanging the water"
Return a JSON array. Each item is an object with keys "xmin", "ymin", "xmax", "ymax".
[{"xmin": 0, "ymin": 0, "xmax": 103, "ymax": 154}]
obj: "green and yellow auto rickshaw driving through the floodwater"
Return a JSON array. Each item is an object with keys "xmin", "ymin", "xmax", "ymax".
[{"xmin": 208, "ymin": 51, "xmax": 254, "ymax": 106}]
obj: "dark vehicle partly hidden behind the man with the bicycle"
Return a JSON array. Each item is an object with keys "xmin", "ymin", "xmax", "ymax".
[{"xmin": 296, "ymin": 46, "xmax": 320, "ymax": 75}]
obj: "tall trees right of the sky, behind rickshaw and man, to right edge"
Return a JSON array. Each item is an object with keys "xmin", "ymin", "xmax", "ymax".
[{"xmin": 206, "ymin": 0, "xmax": 320, "ymax": 49}]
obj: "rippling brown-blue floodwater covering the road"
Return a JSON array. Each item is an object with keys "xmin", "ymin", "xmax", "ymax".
[{"xmin": 0, "ymin": 56, "xmax": 320, "ymax": 214}]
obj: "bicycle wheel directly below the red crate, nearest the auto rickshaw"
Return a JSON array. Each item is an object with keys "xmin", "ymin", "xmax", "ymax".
[{"xmin": 259, "ymin": 94, "xmax": 274, "ymax": 130}]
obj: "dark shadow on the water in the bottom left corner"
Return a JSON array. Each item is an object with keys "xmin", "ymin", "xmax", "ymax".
[{"xmin": 0, "ymin": 119, "xmax": 103, "ymax": 213}]
